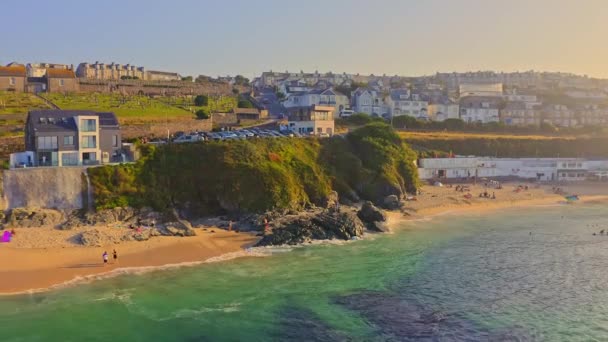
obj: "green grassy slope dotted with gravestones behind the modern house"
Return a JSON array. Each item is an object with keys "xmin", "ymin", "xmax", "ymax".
[{"xmin": 41, "ymin": 93, "xmax": 192, "ymax": 121}]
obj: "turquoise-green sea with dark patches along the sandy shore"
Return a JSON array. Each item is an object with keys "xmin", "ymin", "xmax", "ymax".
[{"xmin": 0, "ymin": 204, "xmax": 608, "ymax": 342}]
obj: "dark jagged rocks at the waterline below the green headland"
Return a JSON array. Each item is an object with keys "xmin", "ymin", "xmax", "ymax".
[{"xmin": 257, "ymin": 211, "xmax": 365, "ymax": 246}]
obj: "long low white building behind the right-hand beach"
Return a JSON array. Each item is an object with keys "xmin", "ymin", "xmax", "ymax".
[{"xmin": 418, "ymin": 157, "xmax": 608, "ymax": 182}]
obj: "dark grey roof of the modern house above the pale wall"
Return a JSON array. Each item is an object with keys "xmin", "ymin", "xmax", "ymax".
[{"xmin": 28, "ymin": 109, "xmax": 119, "ymax": 132}]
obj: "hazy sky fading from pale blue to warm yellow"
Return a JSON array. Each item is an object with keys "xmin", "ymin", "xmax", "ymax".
[{"xmin": 0, "ymin": 0, "xmax": 608, "ymax": 78}]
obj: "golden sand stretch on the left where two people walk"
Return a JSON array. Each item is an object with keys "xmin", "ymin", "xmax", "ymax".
[{"xmin": 0, "ymin": 228, "xmax": 257, "ymax": 294}]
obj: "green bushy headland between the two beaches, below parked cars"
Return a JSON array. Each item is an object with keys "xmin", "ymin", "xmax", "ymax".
[{"xmin": 89, "ymin": 123, "xmax": 418, "ymax": 214}]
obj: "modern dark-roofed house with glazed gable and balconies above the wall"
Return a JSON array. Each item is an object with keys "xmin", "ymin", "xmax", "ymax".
[{"xmin": 11, "ymin": 110, "xmax": 123, "ymax": 167}]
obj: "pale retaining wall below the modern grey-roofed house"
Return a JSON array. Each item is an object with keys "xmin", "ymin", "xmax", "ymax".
[{"xmin": 0, "ymin": 167, "xmax": 85, "ymax": 210}]
